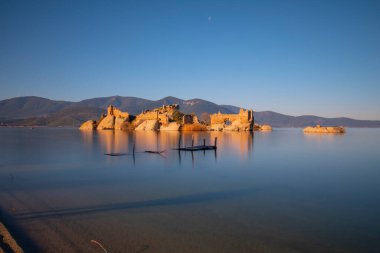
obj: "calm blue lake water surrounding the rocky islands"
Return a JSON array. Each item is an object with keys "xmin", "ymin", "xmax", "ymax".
[{"xmin": 0, "ymin": 128, "xmax": 380, "ymax": 253}]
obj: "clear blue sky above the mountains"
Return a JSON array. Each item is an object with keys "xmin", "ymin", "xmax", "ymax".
[{"xmin": 0, "ymin": 0, "xmax": 380, "ymax": 120}]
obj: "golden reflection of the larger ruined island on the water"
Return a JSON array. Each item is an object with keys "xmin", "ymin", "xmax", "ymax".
[{"xmin": 81, "ymin": 130, "xmax": 254, "ymax": 167}]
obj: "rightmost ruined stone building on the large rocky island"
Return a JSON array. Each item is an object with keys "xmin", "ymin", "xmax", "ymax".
[{"xmin": 210, "ymin": 109, "xmax": 254, "ymax": 131}]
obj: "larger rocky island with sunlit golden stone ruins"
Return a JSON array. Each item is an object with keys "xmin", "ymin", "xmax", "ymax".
[{"xmin": 80, "ymin": 104, "xmax": 272, "ymax": 131}]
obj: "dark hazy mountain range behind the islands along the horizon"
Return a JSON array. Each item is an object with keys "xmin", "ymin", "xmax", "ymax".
[{"xmin": 0, "ymin": 96, "xmax": 380, "ymax": 127}]
